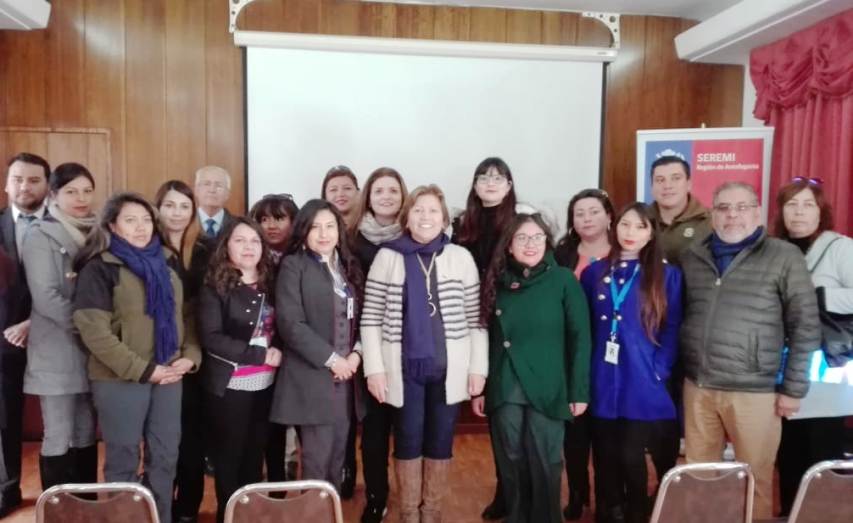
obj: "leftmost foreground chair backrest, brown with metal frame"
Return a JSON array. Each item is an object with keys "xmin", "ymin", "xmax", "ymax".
[{"xmin": 36, "ymin": 483, "xmax": 160, "ymax": 523}]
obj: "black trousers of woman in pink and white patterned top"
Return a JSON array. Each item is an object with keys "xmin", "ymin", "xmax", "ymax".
[{"xmin": 204, "ymin": 387, "xmax": 273, "ymax": 523}]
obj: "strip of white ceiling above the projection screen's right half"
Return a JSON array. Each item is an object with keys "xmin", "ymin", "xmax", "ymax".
[{"xmin": 362, "ymin": 0, "xmax": 748, "ymax": 20}]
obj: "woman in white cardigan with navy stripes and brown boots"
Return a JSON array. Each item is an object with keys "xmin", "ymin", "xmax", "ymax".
[{"xmin": 361, "ymin": 185, "xmax": 488, "ymax": 523}]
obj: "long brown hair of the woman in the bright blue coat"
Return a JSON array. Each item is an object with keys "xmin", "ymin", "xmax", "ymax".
[{"xmin": 608, "ymin": 202, "xmax": 667, "ymax": 345}]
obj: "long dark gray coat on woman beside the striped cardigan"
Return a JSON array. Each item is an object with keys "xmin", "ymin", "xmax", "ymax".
[{"xmin": 270, "ymin": 251, "xmax": 366, "ymax": 425}]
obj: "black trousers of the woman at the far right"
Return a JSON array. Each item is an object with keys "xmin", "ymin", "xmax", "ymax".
[{"xmin": 776, "ymin": 416, "xmax": 844, "ymax": 516}]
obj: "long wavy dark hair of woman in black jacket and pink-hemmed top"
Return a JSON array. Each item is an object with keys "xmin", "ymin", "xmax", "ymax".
[{"xmin": 204, "ymin": 216, "xmax": 275, "ymax": 303}]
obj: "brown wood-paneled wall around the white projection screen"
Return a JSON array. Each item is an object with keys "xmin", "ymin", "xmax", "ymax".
[{"xmin": 0, "ymin": 0, "xmax": 743, "ymax": 210}]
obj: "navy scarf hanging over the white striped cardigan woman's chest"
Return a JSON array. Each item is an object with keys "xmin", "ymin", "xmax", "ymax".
[{"xmin": 382, "ymin": 233, "xmax": 450, "ymax": 379}]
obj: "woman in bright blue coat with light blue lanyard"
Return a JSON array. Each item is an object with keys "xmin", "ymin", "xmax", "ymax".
[{"xmin": 581, "ymin": 202, "xmax": 681, "ymax": 522}]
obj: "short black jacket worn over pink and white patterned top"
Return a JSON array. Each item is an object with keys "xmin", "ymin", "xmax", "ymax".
[{"xmin": 196, "ymin": 285, "xmax": 280, "ymax": 396}]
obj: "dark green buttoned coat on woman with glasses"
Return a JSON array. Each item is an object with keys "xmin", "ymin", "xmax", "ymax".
[{"xmin": 486, "ymin": 253, "xmax": 591, "ymax": 420}]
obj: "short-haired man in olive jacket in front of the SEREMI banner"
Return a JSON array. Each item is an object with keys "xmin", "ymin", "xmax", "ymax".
[{"xmin": 651, "ymin": 151, "xmax": 711, "ymax": 263}]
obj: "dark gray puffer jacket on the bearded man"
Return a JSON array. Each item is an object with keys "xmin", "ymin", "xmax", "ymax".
[{"xmin": 681, "ymin": 233, "xmax": 821, "ymax": 398}]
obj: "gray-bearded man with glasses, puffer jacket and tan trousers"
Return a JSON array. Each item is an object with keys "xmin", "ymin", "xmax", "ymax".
[{"xmin": 680, "ymin": 182, "xmax": 821, "ymax": 519}]
